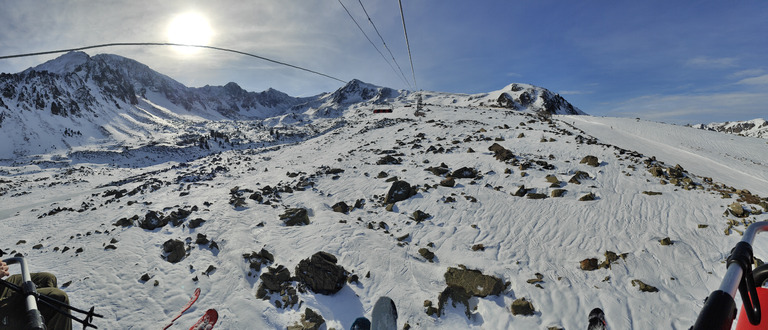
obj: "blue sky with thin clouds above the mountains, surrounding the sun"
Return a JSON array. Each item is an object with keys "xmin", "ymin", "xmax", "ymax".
[{"xmin": 0, "ymin": 0, "xmax": 768, "ymax": 124}]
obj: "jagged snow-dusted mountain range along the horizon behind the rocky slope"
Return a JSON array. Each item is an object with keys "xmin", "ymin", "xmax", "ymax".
[{"xmin": 0, "ymin": 52, "xmax": 585, "ymax": 159}]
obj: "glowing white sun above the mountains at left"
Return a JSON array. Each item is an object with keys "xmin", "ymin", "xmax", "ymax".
[{"xmin": 167, "ymin": 12, "xmax": 213, "ymax": 55}]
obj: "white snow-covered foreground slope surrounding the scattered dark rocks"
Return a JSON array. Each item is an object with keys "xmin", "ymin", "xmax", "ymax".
[{"xmin": 0, "ymin": 93, "xmax": 768, "ymax": 329}]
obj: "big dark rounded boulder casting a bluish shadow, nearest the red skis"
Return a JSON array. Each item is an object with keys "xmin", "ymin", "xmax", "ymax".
[{"xmin": 296, "ymin": 251, "xmax": 349, "ymax": 294}]
